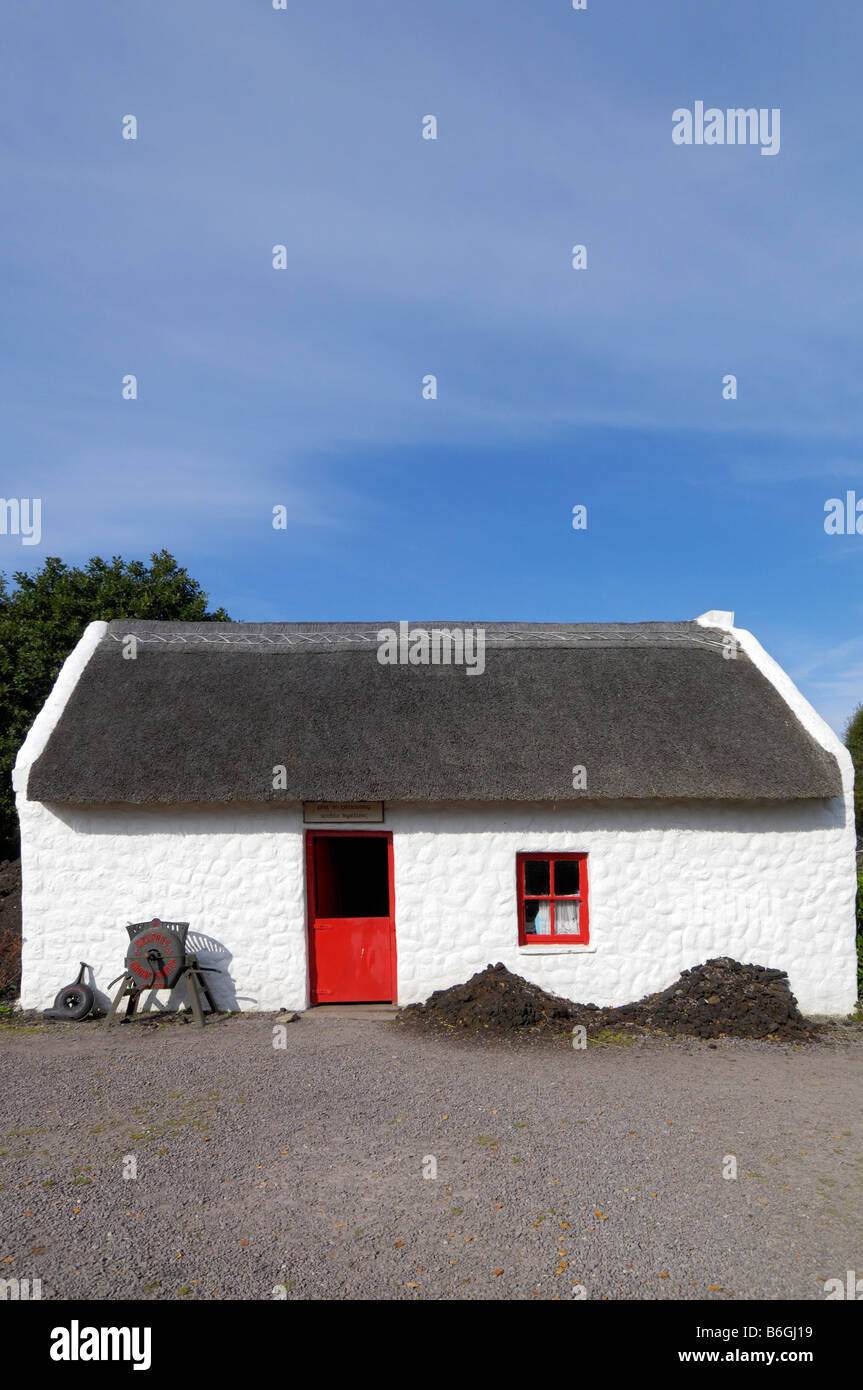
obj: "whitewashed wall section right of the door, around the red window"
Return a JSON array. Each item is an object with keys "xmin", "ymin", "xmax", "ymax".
[{"xmin": 392, "ymin": 801, "xmax": 856, "ymax": 1013}]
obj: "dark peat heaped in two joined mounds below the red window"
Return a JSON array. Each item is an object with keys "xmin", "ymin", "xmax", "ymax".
[{"xmin": 399, "ymin": 956, "xmax": 816, "ymax": 1043}]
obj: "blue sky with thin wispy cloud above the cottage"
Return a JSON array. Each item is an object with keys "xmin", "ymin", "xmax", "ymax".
[{"xmin": 0, "ymin": 0, "xmax": 863, "ymax": 730}]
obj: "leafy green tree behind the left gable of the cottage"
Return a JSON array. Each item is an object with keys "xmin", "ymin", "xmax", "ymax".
[{"xmin": 0, "ymin": 550, "xmax": 228, "ymax": 858}]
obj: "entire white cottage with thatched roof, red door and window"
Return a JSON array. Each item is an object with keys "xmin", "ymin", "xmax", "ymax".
[{"xmin": 14, "ymin": 612, "xmax": 856, "ymax": 1015}]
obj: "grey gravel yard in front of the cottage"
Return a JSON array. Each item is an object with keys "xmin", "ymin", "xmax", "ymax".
[{"xmin": 0, "ymin": 1006, "xmax": 863, "ymax": 1301}]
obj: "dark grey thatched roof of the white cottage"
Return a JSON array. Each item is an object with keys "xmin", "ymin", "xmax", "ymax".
[{"xmin": 28, "ymin": 621, "xmax": 841, "ymax": 802}]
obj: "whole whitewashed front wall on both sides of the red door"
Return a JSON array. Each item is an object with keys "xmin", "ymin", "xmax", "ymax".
[{"xmin": 13, "ymin": 794, "xmax": 856, "ymax": 1013}]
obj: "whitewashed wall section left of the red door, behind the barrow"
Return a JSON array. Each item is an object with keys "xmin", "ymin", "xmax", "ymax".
[{"xmin": 18, "ymin": 798, "xmax": 309, "ymax": 1009}]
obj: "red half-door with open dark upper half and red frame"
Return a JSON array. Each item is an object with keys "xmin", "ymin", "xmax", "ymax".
[{"xmin": 306, "ymin": 830, "xmax": 396, "ymax": 1004}]
